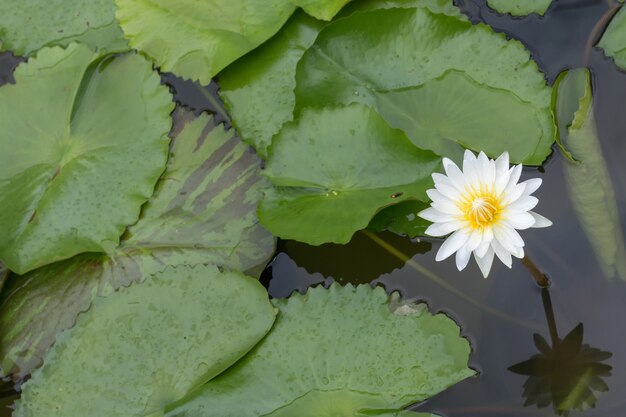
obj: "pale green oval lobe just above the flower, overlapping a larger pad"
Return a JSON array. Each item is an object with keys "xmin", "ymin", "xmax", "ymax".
[{"xmin": 377, "ymin": 71, "xmax": 541, "ymax": 161}]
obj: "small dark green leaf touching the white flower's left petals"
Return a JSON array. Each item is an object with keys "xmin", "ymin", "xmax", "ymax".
[{"xmin": 367, "ymin": 200, "xmax": 430, "ymax": 238}]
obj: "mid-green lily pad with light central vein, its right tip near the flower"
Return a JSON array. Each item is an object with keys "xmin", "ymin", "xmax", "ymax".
[{"xmin": 259, "ymin": 104, "xmax": 439, "ymax": 245}]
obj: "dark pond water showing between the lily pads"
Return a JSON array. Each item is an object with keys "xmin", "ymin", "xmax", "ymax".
[{"xmin": 0, "ymin": 0, "xmax": 626, "ymax": 417}]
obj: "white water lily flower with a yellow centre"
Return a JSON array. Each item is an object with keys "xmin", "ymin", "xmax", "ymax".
[{"xmin": 418, "ymin": 151, "xmax": 552, "ymax": 278}]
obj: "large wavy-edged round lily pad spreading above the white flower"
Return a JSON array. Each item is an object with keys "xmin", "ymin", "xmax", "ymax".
[{"xmin": 296, "ymin": 8, "xmax": 555, "ymax": 165}]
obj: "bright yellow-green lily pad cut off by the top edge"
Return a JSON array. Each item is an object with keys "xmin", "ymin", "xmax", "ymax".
[{"xmin": 115, "ymin": 0, "xmax": 295, "ymax": 84}]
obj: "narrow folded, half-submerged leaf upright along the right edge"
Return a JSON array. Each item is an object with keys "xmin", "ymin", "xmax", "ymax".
[{"xmin": 555, "ymin": 69, "xmax": 626, "ymax": 280}]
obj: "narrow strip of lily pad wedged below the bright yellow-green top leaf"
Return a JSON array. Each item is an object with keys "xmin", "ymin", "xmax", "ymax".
[{"xmin": 220, "ymin": 12, "xmax": 323, "ymax": 158}]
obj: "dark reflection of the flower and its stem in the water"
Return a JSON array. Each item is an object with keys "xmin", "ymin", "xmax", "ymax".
[{"xmin": 509, "ymin": 288, "xmax": 612, "ymax": 416}]
